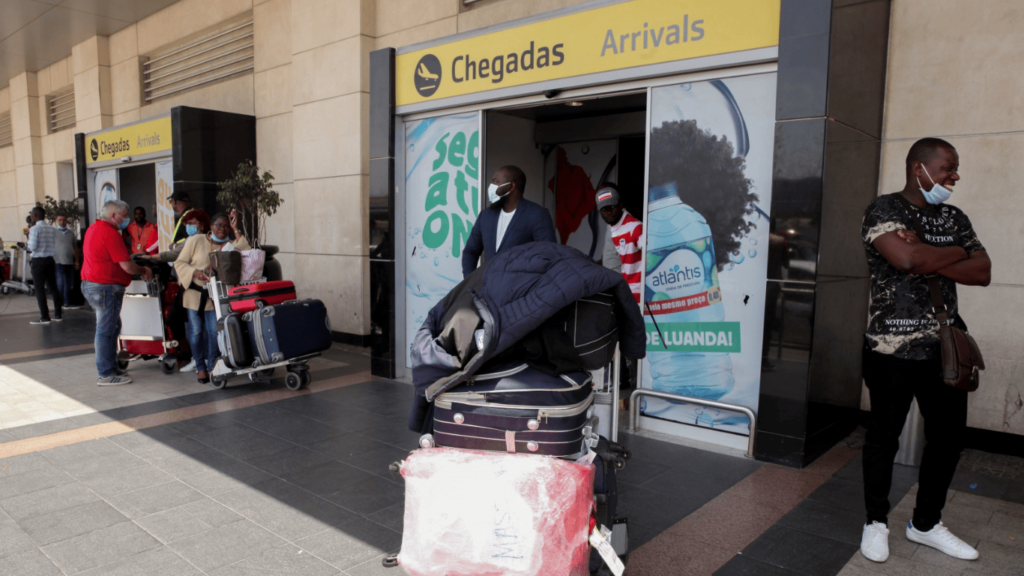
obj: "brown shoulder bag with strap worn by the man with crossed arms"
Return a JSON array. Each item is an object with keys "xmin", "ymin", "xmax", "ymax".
[{"xmin": 897, "ymin": 195, "xmax": 985, "ymax": 392}]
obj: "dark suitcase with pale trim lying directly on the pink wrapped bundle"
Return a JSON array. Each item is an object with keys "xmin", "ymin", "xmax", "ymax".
[{"xmin": 433, "ymin": 364, "xmax": 594, "ymax": 457}]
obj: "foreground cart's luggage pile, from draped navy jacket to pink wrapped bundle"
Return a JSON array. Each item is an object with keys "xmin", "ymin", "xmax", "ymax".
[{"xmin": 384, "ymin": 243, "xmax": 645, "ymax": 576}]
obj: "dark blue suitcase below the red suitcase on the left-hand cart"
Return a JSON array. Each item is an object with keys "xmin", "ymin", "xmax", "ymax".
[{"xmin": 242, "ymin": 300, "xmax": 332, "ymax": 365}]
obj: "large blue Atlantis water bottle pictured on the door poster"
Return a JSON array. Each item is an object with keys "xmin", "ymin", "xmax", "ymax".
[{"xmin": 644, "ymin": 182, "xmax": 735, "ymax": 403}]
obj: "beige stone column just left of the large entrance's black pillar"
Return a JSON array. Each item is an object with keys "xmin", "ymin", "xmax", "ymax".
[{"xmin": 290, "ymin": 0, "xmax": 376, "ymax": 336}]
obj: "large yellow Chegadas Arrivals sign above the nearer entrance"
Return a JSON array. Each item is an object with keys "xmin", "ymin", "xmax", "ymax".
[{"xmin": 395, "ymin": 0, "xmax": 780, "ymax": 106}]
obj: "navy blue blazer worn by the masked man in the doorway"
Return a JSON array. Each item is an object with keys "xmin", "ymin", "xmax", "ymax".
[{"xmin": 462, "ymin": 198, "xmax": 555, "ymax": 277}]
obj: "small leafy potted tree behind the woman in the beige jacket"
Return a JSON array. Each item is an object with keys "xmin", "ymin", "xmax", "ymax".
[{"xmin": 217, "ymin": 160, "xmax": 285, "ymax": 280}]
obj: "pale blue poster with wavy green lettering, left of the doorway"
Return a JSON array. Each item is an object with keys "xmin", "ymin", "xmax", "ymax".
[{"xmin": 406, "ymin": 112, "xmax": 481, "ymax": 366}]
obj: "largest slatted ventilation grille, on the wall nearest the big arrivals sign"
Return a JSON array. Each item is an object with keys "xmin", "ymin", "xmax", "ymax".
[{"xmin": 142, "ymin": 15, "xmax": 253, "ymax": 104}]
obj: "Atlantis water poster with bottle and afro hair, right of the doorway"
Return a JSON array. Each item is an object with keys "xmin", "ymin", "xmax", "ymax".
[{"xmin": 640, "ymin": 74, "xmax": 775, "ymax": 435}]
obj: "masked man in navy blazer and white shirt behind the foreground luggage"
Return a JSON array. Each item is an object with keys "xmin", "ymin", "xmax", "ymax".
[{"xmin": 462, "ymin": 166, "xmax": 555, "ymax": 278}]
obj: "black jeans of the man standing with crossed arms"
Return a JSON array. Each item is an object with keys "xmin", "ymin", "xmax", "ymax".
[{"xmin": 863, "ymin": 349, "xmax": 967, "ymax": 531}]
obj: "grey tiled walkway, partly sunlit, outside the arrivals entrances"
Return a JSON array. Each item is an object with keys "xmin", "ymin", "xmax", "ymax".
[{"xmin": 0, "ymin": 295, "xmax": 1024, "ymax": 576}]
